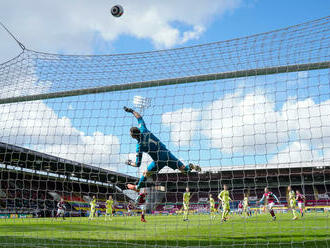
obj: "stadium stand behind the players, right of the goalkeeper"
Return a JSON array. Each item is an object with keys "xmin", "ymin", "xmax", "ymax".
[{"xmin": 154, "ymin": 165, "xmax": 330, "ymax": 212}]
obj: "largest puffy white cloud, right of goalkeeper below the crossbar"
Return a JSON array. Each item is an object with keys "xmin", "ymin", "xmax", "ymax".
[{"xmin": 202, "ymin": 91, "xmax": 289, "ymax": 155}]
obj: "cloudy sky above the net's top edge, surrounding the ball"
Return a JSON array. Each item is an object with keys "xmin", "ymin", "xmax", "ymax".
[{"xmin": 0, "ymin": 0, "xmax": 330, "ymax": 60}]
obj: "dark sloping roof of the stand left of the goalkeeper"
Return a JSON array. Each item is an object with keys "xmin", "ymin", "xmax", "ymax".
[{"xmin": 0, "ymin": 142, "xmax": 137, "ymax": 188}]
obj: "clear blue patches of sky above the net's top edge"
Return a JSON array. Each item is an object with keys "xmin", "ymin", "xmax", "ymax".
[{"xmin": 94, "ymin": 0, "xmax": 330, "ymax": 54}]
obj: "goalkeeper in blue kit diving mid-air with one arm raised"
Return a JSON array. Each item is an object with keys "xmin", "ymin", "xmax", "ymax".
[{"xmin": 124, "ymin": 107, "xmax": 201, "ymax": 191}]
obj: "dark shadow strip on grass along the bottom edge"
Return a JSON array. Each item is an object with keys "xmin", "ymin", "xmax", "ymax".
[{"xmin": 0, "ymin": 235, "xmax": 330, "ymax": 248}]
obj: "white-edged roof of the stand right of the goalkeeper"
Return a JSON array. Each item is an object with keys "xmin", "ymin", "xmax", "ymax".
[{"xmin": 153, "ymin": 161, "xmax": 330, "ymax": 191}]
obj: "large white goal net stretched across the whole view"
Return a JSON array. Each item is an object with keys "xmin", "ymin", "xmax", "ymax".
[{"xmin": 0, "ymin": 17, "xmax": 330, "ymax": 247}]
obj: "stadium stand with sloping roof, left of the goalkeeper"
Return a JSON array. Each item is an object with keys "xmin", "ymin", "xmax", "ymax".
[{"xmin": 0, "ymin": 143, "xmax": 136, "ymax": 217}]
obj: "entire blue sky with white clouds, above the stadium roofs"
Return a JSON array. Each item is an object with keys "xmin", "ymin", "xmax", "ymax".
[{"xmin": 0, "ymin": 0, "xmax": 330, "ymax": 174}]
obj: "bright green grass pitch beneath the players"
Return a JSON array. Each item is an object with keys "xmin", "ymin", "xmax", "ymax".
[{"xmin": 0, "ymin": 213, "xmax": 330, "ymax": 248}]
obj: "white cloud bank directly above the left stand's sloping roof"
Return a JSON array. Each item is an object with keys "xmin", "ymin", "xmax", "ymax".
[{"xmin": 0, "ymin": 67, "xmax": 120, "ymax": 170}]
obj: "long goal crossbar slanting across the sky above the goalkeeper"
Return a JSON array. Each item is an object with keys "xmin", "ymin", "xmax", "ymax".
[{"xmin": 0, "ymin": 61, "xmax": 330, "ymax": 104}]
